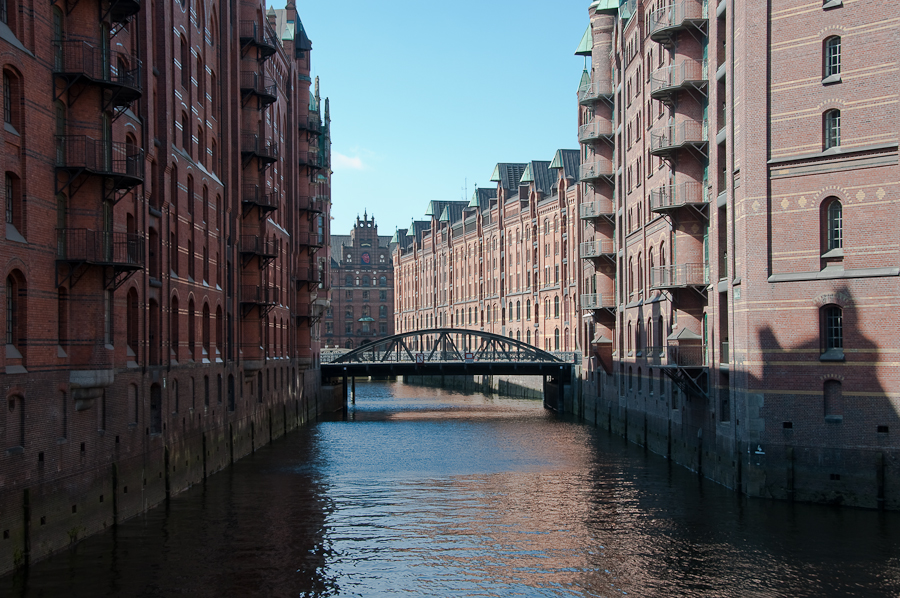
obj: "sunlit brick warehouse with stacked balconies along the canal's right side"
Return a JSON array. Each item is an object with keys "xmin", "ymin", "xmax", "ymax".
[{"xmin": 578, "ymin": 0, "xmax": 900, "ymax": 508}]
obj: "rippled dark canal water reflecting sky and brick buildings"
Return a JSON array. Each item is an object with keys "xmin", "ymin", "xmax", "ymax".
[{"xmin": 0, "ymin": 384, "xmax": 900, "ymax": 597}]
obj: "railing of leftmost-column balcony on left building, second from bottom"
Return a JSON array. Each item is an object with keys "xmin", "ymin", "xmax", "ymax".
[{"xmin": 56, "ymin": 135, "xmax": 144, "ymax": 179}]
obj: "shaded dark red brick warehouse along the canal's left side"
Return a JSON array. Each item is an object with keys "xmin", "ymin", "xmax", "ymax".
[{"xmin": 0, "ymin": 0, "xmax": 330, "ymax": 571}]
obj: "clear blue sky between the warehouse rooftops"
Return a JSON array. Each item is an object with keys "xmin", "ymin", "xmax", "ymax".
[{"xmin": 269, "ymin": 0, "xmax": 590, "ymax": 239}]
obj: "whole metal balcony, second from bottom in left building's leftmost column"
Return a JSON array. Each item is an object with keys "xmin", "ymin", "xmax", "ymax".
[{"xmin": 56, "ymin": 135, "xmax": 144, "ymax": 193}]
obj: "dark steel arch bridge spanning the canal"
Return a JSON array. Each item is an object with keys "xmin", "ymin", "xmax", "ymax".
[{"xmin": 321, "ymin": 328, "xmax": 572, "ymax": 380}]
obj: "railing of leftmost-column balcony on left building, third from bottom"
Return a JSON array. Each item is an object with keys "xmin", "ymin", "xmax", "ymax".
[{"xmin": 53, "ymin": 40, "xmax": 143, "ymax": 91}]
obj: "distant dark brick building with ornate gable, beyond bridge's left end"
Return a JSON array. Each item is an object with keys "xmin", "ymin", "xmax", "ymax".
[{"xmin": 323, "ymin": 214, "xmax": 394, "ymax": 349}]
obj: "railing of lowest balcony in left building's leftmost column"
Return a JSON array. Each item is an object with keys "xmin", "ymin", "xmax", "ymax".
[{"xmin": 56, "ymin": 228, "xmax": 144, "ymax": 268}]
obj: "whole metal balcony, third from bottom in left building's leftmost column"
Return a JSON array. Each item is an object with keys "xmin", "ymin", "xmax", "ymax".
[{"xmin": 53, "ymin": 40, "xmax": 143, "ymax": 108}]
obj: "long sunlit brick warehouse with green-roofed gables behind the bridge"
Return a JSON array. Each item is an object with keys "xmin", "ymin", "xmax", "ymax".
[{"xmin": 394, "ymin": 150, "xmax": 583, "ymax": 351}]
